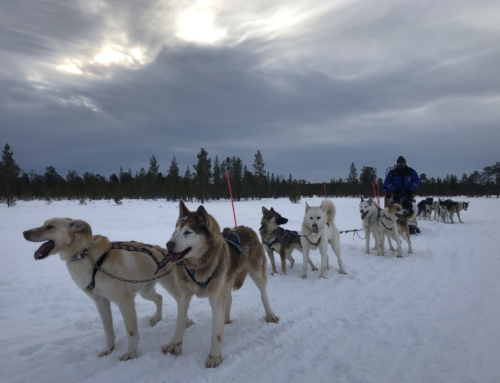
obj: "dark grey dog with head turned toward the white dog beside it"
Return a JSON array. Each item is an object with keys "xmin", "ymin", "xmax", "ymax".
[{"xmin": 259, "ymin": 206, "xmax": 318, "ymax": 275}]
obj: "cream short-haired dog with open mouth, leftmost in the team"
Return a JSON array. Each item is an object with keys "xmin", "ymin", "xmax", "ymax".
[{"xmin": 23, "ymin": 218, "xmax": 184, "ymax": 360}]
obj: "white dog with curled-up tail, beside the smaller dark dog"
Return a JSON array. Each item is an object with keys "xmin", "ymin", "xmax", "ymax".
[{"xmin": 300, "ymin": 199, "xmax": 347, "ymax": 279}]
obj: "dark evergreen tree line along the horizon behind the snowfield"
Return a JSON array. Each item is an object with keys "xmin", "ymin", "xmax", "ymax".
[{"xmin": 0, "ymin": 144, "xmax": 500, "ymax": 206}]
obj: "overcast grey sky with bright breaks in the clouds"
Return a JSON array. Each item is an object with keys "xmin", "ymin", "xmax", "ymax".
[{"xmin": 0, "ymin": 0, "xmax": 500, "ymax": 182}]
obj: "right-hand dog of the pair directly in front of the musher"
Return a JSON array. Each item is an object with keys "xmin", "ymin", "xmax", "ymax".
[{"xmin": 378, "ymin": 200, "xmax": 416, "ymax": 258}]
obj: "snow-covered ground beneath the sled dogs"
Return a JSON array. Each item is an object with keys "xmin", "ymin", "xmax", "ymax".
[{"xmin": 0, "ymin": 198, "xmax": 500, "ymax": 383}]
